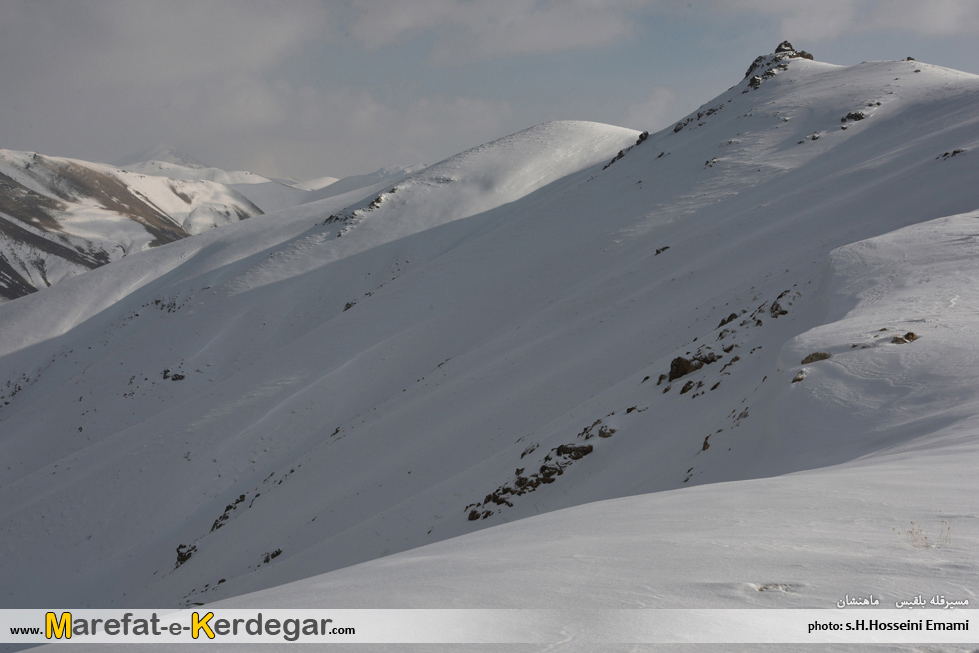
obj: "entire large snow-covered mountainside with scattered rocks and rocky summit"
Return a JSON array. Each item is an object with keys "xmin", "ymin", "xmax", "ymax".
[{"xmin": 0, "ymin": 51, "xmax": 979, "ymax": 648}]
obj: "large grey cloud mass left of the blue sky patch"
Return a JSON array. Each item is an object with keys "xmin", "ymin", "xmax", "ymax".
[{"xmin": 0, "ymin": 0, "xmax": 528, "ymax": 176}]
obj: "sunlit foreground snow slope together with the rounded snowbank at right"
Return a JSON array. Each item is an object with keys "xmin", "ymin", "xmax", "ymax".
[{"xmin": 193, "ymin": 211, "xmax": 979, "ymax": 651}]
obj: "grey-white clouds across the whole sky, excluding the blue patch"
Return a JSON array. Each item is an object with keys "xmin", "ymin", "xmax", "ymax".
[{"xmin": 0, "ymin": 0, "xmax": 979, "ymax": 176}]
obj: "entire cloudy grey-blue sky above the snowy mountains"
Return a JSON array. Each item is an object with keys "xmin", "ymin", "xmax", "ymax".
[{"xmin": 0, "ymin": 0, "xmax": 979, "ymax": 179}]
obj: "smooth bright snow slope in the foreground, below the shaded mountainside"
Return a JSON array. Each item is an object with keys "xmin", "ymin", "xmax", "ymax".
[{"xmin": 67, "ymin": 394, "xmax": 979, "ymax": 653}]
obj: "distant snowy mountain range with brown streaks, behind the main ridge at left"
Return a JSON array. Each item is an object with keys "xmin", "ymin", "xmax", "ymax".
[{"xmin": 0, "ymin": 145, "xmax": 424, "ymax": 302}]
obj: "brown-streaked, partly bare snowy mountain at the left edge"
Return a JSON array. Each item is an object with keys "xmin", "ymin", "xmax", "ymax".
[{"xmin": 0, "ymin": 150, "xmax": 261, "ymax": 300}]
